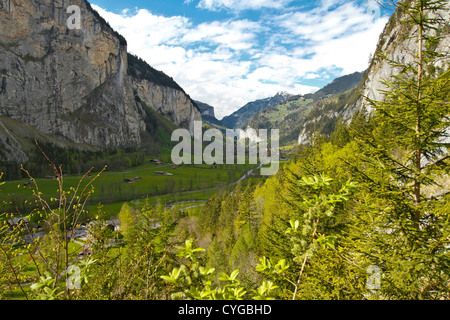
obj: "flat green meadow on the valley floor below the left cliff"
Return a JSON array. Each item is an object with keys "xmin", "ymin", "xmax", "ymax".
[{"xmin": 0, "ymin": 159, "xmax": 260, "ymax": 219}]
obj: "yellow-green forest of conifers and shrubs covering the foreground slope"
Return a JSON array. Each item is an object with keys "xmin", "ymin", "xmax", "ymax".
[{"xmin": 0, "ymin": 0, "xmax": 450, "ymax": 300}]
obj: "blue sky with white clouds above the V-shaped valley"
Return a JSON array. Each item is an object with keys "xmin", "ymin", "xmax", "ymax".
[{"xmin": 90, "ymin": 0, "xmax": 392, "ymax": 119}]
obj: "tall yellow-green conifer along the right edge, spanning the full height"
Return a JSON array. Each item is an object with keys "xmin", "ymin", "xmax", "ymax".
[{"xmin": 346, "ymin": 0, "xmax": 450, "ymax": 299}]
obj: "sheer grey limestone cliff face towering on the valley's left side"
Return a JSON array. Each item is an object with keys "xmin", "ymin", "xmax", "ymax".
[{"xmin": 0, "ymin": 0, "xmax": 199, "ymax": 160}]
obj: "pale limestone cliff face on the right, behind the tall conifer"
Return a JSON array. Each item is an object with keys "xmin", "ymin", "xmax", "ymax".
[{"xmin": 298, "ymin": 6, "xmax": 450, "ymax": 144}]
